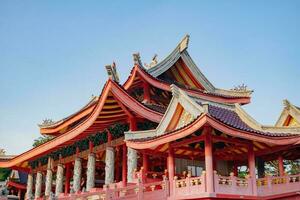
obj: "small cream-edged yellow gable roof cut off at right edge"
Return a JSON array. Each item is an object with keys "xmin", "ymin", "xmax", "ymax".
[{"xmin": 275, "ymin": 100, "xmax": 300, "ymax": 127}]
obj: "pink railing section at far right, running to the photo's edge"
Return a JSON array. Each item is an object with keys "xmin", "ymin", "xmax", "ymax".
[{"xmin": 256, "ymin": 174, "xmax": 300, "ymax": 196}]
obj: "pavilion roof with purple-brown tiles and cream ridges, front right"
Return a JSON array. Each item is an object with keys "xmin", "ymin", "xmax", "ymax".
[{"xmin": 125, "ymin": 86, "xmax": 300, "ymax": 149}]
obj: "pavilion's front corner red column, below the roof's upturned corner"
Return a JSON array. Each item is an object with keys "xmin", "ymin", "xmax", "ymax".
[{"xmin": 204, "ymin": 130, "xmax": 214, "ymax": 193}]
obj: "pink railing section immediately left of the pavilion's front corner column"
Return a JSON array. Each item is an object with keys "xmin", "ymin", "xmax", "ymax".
[{"xmin": 171, "ymin": 172, "xmax": 205, "ymax": 199}]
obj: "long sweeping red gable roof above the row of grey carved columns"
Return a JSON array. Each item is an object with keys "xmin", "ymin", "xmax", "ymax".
[{"xmin": 0, "ymin": 80, "xmax": 162, "ymax": 168}]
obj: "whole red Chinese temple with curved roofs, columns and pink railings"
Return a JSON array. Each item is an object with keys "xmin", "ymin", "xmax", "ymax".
[{"xmin": 0, "ymin": 36, "xmax": 300, "ymax": 200}]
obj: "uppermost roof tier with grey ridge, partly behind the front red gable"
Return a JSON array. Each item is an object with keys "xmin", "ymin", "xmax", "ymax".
[{"xmin": 39, "ymin": 35, "xmax": 252, "ymax": 136}]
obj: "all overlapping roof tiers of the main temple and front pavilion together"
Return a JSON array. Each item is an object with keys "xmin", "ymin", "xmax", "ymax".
[{"xmin": 0, "ymin": 36, "xmax": 300, "ymax": 168}]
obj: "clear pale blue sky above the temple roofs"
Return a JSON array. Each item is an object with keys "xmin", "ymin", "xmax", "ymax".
[{"xmin": 0, "ymin": 0, "xmax": 300, "ymax": 154}]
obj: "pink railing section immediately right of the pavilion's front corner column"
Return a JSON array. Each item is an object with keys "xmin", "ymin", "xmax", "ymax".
[{"xmin": 214, "ymin": 171, "xmax": 253, "ymax": 196}]
